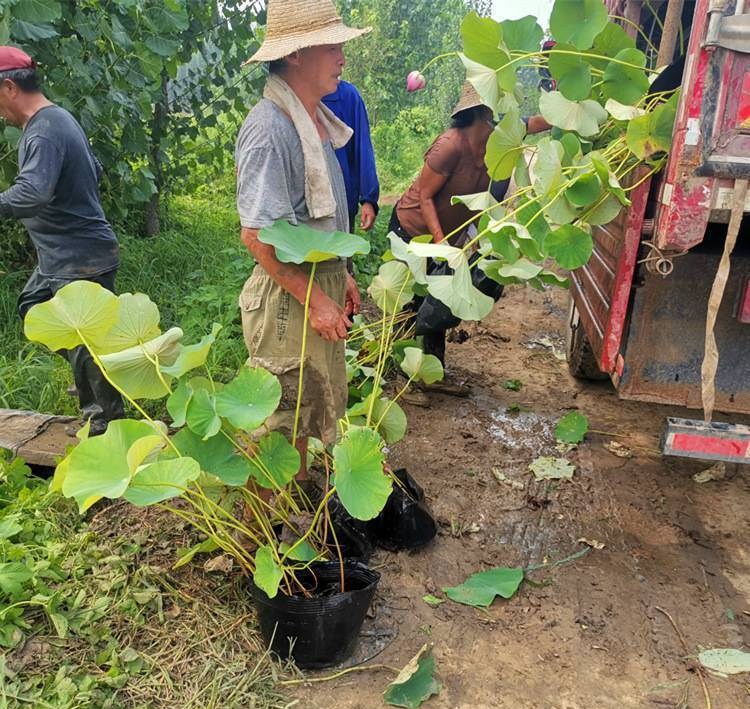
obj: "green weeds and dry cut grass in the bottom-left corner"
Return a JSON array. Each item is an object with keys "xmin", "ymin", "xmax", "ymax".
[{"xmin": 0, "ymin": 455, "xmax": 289, "ymax": 709}]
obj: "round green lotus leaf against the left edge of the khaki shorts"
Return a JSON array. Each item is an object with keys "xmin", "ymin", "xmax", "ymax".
[{"xmin": 216, "ymin": 367, "xmax": 281, "ymax": 432}]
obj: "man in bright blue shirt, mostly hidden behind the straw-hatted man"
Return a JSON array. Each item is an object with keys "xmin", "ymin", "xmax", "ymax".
[{"xmin": 323, "ymin": 81, "xmax": 380, "ymax": 231}]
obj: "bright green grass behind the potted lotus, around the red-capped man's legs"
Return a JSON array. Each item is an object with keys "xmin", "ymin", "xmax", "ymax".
[{"xmin": 0, "ymin": 181, "xmax": 253, "ymax": 414}]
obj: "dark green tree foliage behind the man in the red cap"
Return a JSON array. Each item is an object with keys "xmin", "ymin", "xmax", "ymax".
[{"xmin": 0, "ymin": 0, "xmax": 263, "ymax": 228}]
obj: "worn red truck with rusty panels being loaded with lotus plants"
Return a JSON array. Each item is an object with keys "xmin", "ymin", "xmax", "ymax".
[{"xmin": 568, "ymin": 0, "xmax": 750, "ymax": 463}]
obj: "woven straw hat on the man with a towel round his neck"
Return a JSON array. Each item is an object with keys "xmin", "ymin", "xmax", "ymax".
[{"xmin": 248, "ymin": 0, "xmax": 372, "ymax": 62}]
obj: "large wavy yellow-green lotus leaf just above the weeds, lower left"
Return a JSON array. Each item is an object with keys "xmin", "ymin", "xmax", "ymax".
[{"xmin": 62, "ymin": 419, "xmax": 164, "ymax": 512}]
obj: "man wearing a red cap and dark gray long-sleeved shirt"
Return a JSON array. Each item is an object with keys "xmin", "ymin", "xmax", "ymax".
[{"xmin": 0, "ymin": 46, "xmax": 124, "ymax": 435}]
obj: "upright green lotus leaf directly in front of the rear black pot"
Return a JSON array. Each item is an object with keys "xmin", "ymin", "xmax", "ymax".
[{"xmin": 333, "ymin": 428, "xmax": 393, "ymax": 520}]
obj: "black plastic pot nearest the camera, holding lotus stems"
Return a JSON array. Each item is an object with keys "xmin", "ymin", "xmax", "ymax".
[{"xmin": 251, "ymin": 560, "xmax": 380, "ymax": 669}]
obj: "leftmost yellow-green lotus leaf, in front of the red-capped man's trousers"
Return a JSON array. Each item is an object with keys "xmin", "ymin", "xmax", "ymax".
[{"xmin": 24, "ymin": 281, "xmax": 119, "ymax": 351}]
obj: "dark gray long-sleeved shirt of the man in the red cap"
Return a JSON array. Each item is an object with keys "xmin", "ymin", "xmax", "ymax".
[{"xmin": 0, "ymin": 106, "xmax": 119, "ymax": 278}]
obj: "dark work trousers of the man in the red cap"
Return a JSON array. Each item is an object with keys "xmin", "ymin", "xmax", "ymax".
[{"xmin": 18, "ymin": 269, "xmax": 125, "ymax": 421}]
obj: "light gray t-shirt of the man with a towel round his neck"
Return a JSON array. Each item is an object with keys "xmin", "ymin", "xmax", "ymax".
[{"xmin": 235, "ymin": 99, "xmax": 349, "ymax": 231}]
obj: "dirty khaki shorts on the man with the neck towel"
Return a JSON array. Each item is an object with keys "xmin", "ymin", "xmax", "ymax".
[{"xmin": 240, "ymin": 261, "xmax": 348, "ymax": 444}]
